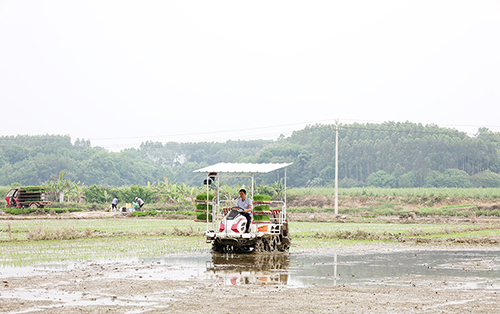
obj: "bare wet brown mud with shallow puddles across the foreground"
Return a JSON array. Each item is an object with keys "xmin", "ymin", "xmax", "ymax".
[{"xmin": 0, "ymin": 244, "xmax": 500, "ymax": 313}]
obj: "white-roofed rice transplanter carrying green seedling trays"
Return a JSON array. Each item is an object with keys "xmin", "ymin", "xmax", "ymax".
[{"xmin": 193, "ymin": 163, "xmax": 291, "ymax": 252}]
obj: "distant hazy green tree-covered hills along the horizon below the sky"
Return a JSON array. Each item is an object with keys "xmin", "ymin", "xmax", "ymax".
[{"xmin": 0, "ymin": 122, "xmax": 500, "ymax": 188}]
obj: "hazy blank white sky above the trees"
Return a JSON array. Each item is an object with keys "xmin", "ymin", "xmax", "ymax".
[{"xmin": 0, "ymin": 0, "xmax": 500, "ymax": 151}]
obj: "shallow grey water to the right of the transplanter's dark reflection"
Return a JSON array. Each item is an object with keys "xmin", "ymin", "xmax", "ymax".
[{"xmin": 288, "ymin": 250, "xmax": 500, "ymax": 289}]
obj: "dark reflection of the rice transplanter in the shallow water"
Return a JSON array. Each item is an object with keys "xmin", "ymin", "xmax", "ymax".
[{"xmin": 207, "ymin": 253, "xmax": 290, "ymax": 285}]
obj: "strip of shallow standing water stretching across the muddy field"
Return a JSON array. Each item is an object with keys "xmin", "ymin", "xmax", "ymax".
[{"xmin": 0, "ymin": 250, "xmax": 500, "ymax": 289}]
